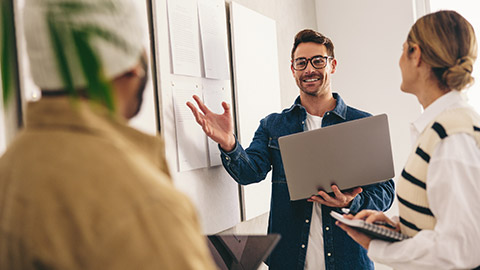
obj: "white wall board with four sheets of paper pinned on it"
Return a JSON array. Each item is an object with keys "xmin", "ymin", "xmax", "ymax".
[{"xmin": 148, "ymin": 0, "xmax": 240, "ymax": 234}]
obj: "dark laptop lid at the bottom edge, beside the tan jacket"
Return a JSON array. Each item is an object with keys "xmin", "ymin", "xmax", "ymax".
[{"xmin": 208, "ymin": 234, "xmax": 280, "ymax": 270}]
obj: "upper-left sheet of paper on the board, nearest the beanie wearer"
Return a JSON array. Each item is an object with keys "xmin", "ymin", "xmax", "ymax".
[{"xmin": 167, "ymin": 0, "xmax": 202, "ymax": 77}]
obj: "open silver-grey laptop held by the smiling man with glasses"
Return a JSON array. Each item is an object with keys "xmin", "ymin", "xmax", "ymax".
[{"xmin": 278, "ymin": 114, "xmax": 395, "ymax": 201}]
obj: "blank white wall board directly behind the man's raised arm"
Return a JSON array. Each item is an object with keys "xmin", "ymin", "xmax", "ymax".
[{"xmin": 230, "ymin": 2, "xmax": 281, "ymax": 220}]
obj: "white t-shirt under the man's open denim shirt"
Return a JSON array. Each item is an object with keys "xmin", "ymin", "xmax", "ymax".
[{"xmin": 305, "ymin": 113, "xmax": 325, "ymax": 270}]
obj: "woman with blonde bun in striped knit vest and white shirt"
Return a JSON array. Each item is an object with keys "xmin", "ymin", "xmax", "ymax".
[{"xmin": 338, "ymin": 11, "xmax": 480, "ymax": 269}]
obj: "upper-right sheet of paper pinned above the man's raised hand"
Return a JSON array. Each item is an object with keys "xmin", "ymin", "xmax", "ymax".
[{"xmin": 198, "ymin": 0, "xmax": 230, "ymax": 80}]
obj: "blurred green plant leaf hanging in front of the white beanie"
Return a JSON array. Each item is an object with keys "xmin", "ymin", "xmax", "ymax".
[{"xmin": 47, "ymin": 1, "xmax": 132, "ymax": 112}]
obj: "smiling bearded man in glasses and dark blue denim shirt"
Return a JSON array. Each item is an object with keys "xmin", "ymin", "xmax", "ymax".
[{"xmin": 187, "ymin": 29, "xmax": 395, "ymax": 270}]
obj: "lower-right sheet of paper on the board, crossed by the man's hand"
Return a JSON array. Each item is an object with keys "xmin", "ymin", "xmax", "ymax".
[{"xmin": 203, "ymin": 80, "xmax": 233, "ymax": 166}]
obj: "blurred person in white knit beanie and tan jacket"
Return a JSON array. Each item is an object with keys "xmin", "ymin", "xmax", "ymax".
[{"xmin": 0, "ymin": 0, "xmax": 216, "ymax": 270}]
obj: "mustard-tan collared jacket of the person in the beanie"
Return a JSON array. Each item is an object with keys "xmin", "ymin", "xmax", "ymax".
[{"xmin": 0, "ymin": 97, "xmax": 215, "ymax": 270}]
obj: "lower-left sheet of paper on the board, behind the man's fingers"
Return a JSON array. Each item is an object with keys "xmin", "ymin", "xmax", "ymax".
[{"xmin": 171, "ymin": 81, "xmax": 208, "ymax": 172}]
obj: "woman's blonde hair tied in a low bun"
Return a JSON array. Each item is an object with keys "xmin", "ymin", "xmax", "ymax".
[{"xmin": 407, "ymin": 10, "xmax": 477, "ymax": 90}]
